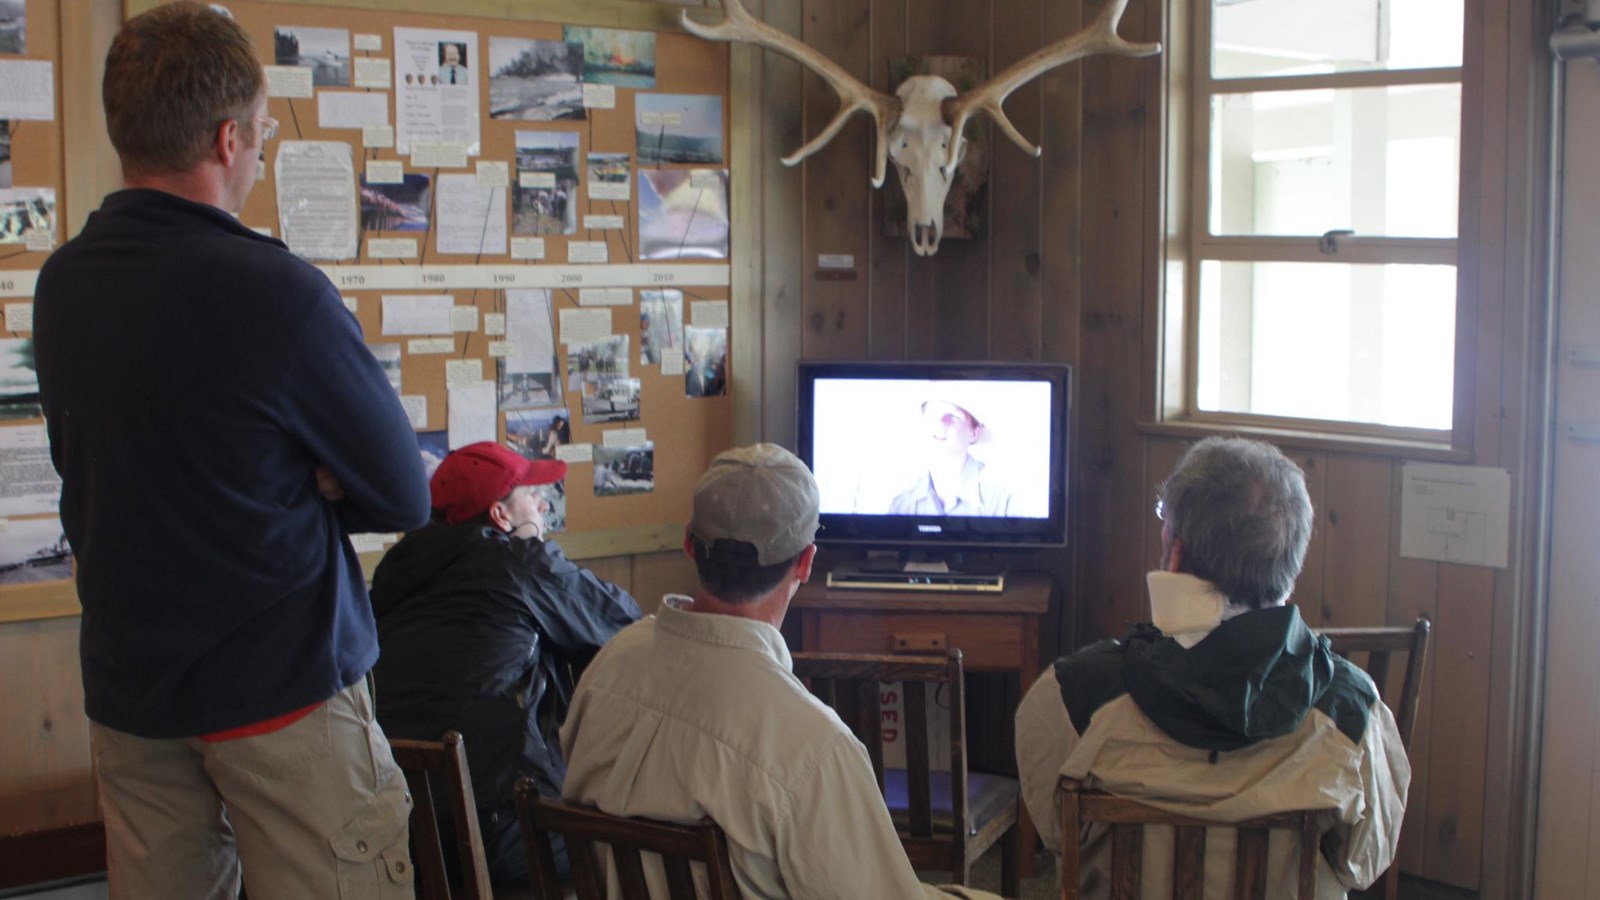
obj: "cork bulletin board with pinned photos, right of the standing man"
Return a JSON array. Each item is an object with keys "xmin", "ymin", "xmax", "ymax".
[{"xmin": 128, "ymin": 0, "xmax": 738, "ymax": 556}]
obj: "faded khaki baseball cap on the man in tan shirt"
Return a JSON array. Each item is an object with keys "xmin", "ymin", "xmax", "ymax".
[{"xmin": 690, "ymin": 444, "xmax": 819, "ymax": 565}]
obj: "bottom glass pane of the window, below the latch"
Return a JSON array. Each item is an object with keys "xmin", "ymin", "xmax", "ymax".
[{"xmin": 1197, "ymin": 261, "xmax": 1456, "ymax": 431}]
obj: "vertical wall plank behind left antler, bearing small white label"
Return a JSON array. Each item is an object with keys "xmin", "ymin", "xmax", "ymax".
[{"xmin": 800, "ymin": 0, "xmax": 872, "ymax": 359}]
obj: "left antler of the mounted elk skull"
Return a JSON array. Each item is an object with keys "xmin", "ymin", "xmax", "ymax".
[{"xmin": 682, "ymin": 0, "xmax": 902, "ymax": 187}]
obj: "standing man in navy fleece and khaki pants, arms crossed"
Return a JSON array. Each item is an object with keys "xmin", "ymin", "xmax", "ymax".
[{"xmin": 35, "ymin": 3, "xmax": 429, "ymax": 900}]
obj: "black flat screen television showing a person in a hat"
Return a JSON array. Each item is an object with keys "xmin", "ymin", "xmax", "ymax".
[{"xmin": 797, "ymin": 362, "xmax": 1072, "ymax": 552}]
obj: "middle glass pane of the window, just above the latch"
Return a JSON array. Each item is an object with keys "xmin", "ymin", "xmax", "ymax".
[{"xmin": 1210, "ymin": 85, "xmax": 1461, "ymax": 237}]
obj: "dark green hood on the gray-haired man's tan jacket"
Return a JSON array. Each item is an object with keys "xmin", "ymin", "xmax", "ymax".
[{"xmin": 1122, "ymin": 605, "xmax": 1334, "ymax": 751}]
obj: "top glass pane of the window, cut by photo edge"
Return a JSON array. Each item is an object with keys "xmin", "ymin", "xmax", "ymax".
[{"xmin": 1211, "ymin": 0, "xmax": 1464, "ymax": 78}]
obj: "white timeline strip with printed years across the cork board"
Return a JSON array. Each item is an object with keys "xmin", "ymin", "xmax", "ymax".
[{"xmin": 315, "ymin": 264, "xmax": 731, "ymax": 288}]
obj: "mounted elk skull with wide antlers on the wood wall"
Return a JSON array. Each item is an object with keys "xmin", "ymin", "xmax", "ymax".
[{"xmin": 682, "ymin": 0, "xmax": 1162, "ymax": 256}]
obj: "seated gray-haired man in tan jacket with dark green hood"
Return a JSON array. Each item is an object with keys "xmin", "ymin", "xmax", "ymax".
[{"xmin": 1016, "ymin": 437, "xmax": 1411, "ymax": 900}]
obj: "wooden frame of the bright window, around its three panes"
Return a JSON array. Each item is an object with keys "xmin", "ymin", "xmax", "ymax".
[{"xmin": 1144, "ymin": 0, "xmax": 1483, "ymax": 448}]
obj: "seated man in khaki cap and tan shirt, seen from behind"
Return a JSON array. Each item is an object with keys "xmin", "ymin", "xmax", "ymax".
[{"xmin": 562, "ymin": 444, "xmax": 984, "ymax": 900}]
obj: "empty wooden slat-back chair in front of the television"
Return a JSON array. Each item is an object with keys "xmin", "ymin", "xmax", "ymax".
[{"xmin": 794, "ymin": 650, "xmax": 1021, "ymax": 897}]
